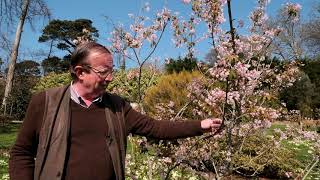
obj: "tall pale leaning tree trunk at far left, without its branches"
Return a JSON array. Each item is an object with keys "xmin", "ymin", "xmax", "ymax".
[{"xmin": 1, "ymin": 0, "xmax": 30, "ymax": 114}]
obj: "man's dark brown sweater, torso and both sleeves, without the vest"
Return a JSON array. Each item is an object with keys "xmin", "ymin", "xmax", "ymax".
[{"xmin": 9, "ymin": 90, "xmax": 202, "ymax": 180}]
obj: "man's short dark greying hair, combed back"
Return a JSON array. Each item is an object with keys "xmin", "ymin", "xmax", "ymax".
[{"xmin": 70, "ymin": 42, "xmax": 111, "ymax": 80}]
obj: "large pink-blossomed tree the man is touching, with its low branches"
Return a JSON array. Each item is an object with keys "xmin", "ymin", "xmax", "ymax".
[{"xmin": 124, "ymin": 0, "xmax": 319, "ymax": 179}]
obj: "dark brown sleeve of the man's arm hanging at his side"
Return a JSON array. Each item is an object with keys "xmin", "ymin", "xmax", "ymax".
[{"xmin": 9, "ymin": 93, "xmax": 45, "ymax": 180}]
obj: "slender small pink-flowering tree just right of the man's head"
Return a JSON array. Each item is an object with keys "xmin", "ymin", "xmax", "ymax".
[{"xmin": 110, "ymin": 6, "xmax": 171, "ymax": 103}]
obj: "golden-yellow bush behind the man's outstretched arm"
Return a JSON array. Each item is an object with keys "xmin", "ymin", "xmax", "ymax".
[{"xmin": 144, "ymin": 71, "xmax": 201, "ymax": 115}]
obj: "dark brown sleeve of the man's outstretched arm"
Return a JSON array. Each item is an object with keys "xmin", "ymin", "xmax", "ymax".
[{"xmin": 124, "ymin": 103, "xmax": 203, "ymax": 139}]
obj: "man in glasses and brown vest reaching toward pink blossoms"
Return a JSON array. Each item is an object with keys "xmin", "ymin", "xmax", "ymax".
[{"xmin": 9, "ymin": 42, "xmax": 221, "ymax": 180}]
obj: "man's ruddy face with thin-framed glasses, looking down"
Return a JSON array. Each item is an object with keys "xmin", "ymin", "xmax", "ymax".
[{"xmin": 79, "ymin": 52, "xmax": 113, "ymax": 97}]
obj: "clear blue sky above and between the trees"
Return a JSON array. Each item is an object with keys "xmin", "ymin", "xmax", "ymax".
[{"xmin": 0, "ymin": 0, "xmax": 318, "ymax": 69}]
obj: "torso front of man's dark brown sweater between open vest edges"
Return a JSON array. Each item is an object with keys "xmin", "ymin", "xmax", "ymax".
[{"xmin": 65, "ymin": 101, "xmax": 114, "ymax": 180}]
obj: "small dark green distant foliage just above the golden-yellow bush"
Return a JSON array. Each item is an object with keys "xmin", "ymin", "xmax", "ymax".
[{"xmin": 165, "ymin": 57, "xmax": 197, "ymax": 73}]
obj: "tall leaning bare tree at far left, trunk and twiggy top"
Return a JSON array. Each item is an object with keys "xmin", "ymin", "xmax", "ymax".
[{"xmin": 0, "ymin": 0, "xmax": 50, "ymax": 114}]
